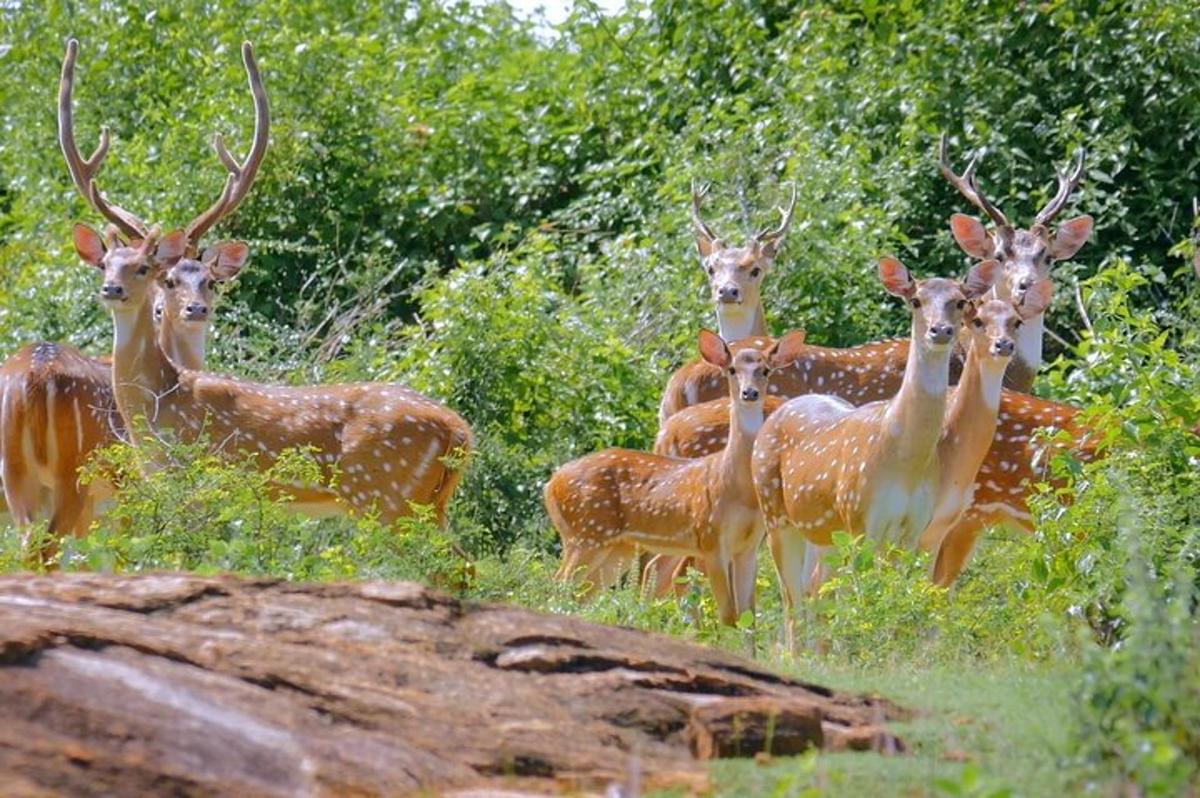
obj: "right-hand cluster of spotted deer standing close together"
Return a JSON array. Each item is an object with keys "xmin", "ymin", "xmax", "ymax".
[{"xmin": 545, "ymin": 138, "xmax": 1096, "ymax": 640}]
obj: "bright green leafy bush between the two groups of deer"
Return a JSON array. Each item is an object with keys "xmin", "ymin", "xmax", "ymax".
[{"xmin": 380, "ymin": 239, "xmax": 662, "ymax": 548}]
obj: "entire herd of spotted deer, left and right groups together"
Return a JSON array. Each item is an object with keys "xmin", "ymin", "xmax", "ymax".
[{"xmin": 0, "ymin": 40, "xmax": 1161, "ymax": 648}]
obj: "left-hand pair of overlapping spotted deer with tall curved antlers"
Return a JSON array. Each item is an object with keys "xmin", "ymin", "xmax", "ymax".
[{"xmin": 0, "ymin": 40, "xmax": 473, "ymax": 560}]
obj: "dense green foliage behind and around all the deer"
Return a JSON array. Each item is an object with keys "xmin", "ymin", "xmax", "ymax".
[{"xmin": 0, "ymin": 0, "xmax": 1200, "ymax": 794}]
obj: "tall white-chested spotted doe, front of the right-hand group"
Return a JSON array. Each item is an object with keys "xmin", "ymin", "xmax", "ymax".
[{"xmin": 752, "ymin": 258, "xmax": 998, "ymax": 640}]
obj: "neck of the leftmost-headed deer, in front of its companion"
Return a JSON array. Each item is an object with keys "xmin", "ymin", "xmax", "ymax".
[{"xmin": 113, "ymin": 295, "xmax": 179, "ymax": 428}]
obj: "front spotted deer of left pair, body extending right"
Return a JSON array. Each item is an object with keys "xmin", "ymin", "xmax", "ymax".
[{"xmin": 64, "ymin": 43, "xmax": 472, "ymax": 524}]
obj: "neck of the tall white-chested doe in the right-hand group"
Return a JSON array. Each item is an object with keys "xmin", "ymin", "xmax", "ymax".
[{"xmin": 884, "ymin": 322, "xmax": 952, "ymax": 468}]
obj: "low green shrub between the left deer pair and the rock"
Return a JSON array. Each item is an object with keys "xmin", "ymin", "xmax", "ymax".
[{"xmin": 5, "ymin": 439, "xmax": 469, "ymax": 586}]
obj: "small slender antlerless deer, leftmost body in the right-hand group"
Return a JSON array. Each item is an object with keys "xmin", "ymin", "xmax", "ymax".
[{"xmin": 545, "ymin": 330, "xmax": 802, "ymax": 624}]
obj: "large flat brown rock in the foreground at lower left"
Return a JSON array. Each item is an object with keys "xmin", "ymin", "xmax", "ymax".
[{"xmin": 0, "ymin": 575, "xmax": 900, "ymax": 796}]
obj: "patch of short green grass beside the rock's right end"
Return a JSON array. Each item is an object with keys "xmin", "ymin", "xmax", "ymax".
[{"xmin": 713, "ymin": 661, "xmax": 1081, "ymax": 796}]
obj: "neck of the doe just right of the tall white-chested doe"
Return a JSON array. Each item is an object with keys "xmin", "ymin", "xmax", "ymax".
[{"xmin": 938, "ymin": 343, "xmax": 1008, "ymax": 479}]
